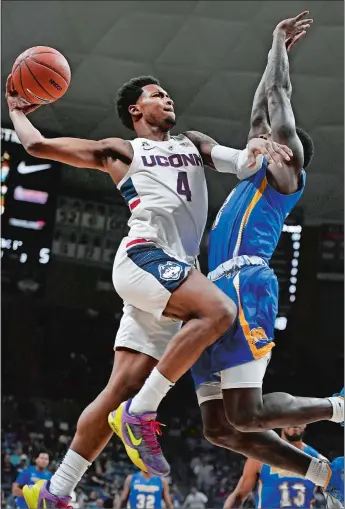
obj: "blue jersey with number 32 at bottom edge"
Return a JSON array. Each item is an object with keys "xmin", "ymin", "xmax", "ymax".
[{"xmin": 128, "ymin": 472, "xmax": 163, "ymax": 509}]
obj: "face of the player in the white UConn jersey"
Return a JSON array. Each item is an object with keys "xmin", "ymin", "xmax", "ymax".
[{"xmin": 137, "ymin": 85, "xmax": 176, "ymax": 129}]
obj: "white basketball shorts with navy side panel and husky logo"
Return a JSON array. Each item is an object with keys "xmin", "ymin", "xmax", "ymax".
[{"xmin": 113, "ymin": 237, "xmax": 192, "ymax": 359}]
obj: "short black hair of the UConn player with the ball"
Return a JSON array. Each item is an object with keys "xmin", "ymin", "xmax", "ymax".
[{"xmin": 116, "ymin": 76, "xmax": 160, "ymax": 131}]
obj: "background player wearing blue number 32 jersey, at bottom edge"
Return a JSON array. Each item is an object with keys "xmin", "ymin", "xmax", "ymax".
[{"xmin": 116, "ymin": 471, "xmax": 172, "ymax": 509}]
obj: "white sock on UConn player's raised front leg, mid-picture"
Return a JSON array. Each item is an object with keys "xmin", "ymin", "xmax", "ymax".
[{"xmin": 129, "ymin": 368, "xmax": 175, "ymax": 414}]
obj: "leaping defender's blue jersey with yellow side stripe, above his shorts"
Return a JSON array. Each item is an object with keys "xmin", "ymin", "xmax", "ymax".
[{"xmin": 208, "ymin": 158, "xmax": 306, "ymax": 271}]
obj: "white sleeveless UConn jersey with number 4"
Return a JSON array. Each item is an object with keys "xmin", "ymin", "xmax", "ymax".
[{"xmin": 117, "ymin": 134, "xmax": 208, "ymax": 263}]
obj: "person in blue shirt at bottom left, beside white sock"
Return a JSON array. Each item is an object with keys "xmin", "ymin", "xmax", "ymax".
[{"xmin": 12, "ymin": 450, "xmax": 52, "ymax": 509}]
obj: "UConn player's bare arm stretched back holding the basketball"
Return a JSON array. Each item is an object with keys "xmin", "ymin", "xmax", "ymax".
[{"xmin": 6, "ymin": 76, "xmax": 133, "ymax": 183}]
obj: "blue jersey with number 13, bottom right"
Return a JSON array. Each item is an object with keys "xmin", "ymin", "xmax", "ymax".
[{"xmin": 256, "ymin": 445, "xmax": 318, "ymax": 509}]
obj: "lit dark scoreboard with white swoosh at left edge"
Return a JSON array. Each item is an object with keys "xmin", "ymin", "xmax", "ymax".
[{"xmin": 0, "ymin": 128, "xmax": 61, "ymax": 277}]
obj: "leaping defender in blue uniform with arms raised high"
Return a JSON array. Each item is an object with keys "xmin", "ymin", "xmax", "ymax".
[{"xmin": 192, "ymin": 11, "xmax": 344, "ymax": 499}]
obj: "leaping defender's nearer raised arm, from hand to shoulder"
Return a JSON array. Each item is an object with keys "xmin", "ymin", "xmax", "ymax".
[{"xmin": 265, "ymin": 11, "xmax": 312, "ymax": 171}]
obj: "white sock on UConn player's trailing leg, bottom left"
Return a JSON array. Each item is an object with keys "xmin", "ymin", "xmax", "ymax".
[{"xmin": 49, "ymin": 449, "xmax": 91, "ymax": 497}]
